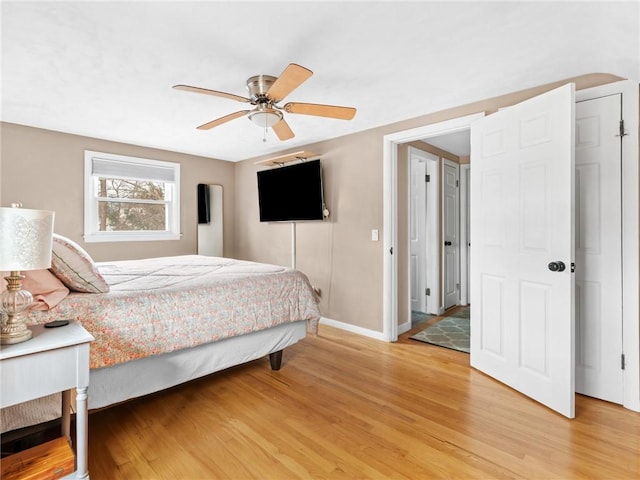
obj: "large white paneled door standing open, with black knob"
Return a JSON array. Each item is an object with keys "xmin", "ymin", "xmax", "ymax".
[{"xmin": 471, "ymin": 84, "xmax": 575, "ymax": 418}]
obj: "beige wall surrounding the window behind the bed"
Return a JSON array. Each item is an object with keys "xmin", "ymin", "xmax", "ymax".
[{"xmin": 0, "ymin": 123, "xmax": 235, "ymax": 261}]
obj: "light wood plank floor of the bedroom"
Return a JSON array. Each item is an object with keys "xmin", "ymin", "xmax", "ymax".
[{"xmin": 89, "ymin": 325, "xmax": 640, "ymax": 480}]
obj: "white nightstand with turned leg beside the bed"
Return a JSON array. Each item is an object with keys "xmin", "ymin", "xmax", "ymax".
[{"xmin": 0, "ymin": 322, "xmax": 94, "ymax": 478}]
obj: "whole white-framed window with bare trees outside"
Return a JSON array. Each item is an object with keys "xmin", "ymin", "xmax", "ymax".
[{"xmin": 84, "ymin": 150, "xmax": 180, "ymax": 242}]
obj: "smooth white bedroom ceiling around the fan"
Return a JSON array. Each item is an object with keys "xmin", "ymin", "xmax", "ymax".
[{"xmin": 0, "ymin": 0, "xmax": 640, "ymax": 161}]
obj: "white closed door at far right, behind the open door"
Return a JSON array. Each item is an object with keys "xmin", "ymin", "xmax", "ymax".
[{"xmin": 576, "ymin": 94, "xmax": 623, "ymax": 403}]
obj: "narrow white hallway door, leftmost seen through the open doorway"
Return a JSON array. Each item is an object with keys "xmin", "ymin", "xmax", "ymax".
[{"xmin": 409, "ymin": 152, "xmax": 427, "ymax": 312}]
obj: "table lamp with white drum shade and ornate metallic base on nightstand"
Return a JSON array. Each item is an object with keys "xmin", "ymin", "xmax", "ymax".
[{"xmin": 0, "ymin": 204, "xmax": 54, "ymax": 344}]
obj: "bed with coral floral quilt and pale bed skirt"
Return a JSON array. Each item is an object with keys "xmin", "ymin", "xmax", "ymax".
[{"xmin": 1, "ymin": 240, "xmax": 320, "ymax": 432}]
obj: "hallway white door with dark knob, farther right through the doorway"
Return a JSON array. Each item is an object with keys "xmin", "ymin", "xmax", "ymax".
[{"xmin": 442, "ymin": 160, "xmax": 460, "ymax": 310}]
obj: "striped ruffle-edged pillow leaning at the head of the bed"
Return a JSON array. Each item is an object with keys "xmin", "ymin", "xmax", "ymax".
[{"xmin": 51, "ymin": 233, "xmax": 109, "ymax": 293}]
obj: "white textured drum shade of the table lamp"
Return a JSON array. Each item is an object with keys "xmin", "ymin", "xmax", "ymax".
[{"xmin": 0, "ymin": 207, "xmax": 54, "ymax": 271}]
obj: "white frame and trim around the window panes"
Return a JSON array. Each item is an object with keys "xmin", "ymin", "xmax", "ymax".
[{"xmin": 84, "ymin": 150, "xmax": 182, "ymax": 243}]
